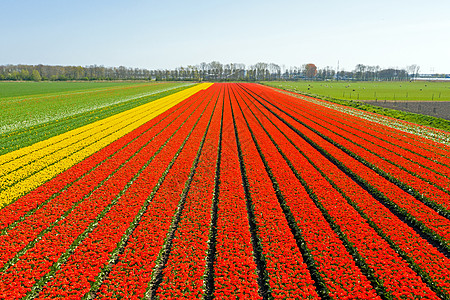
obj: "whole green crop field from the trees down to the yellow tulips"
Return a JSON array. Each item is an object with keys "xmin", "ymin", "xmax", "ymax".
[{"xmin": 0, "ymin": 82, "xmax": 192, "ymax": 155}]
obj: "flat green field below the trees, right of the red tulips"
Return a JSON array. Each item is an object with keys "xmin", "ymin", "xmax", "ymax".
[{"xmin": 263, "ymin": 81, "xmax": 450, "ymax": 101}]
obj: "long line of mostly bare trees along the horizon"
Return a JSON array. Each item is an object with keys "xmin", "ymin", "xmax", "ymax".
[{"xmin": 0, "ymin": 61, "xmax": 420, "ymax": 81}]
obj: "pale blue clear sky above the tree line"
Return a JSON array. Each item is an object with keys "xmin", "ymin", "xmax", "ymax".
[{"xmin": 0, "ymin": 0, "xmax": 450, "ymax": 73}]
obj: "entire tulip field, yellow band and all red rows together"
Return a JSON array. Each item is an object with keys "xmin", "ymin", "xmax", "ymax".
[{"xmin": 0, "ymin": 83, "xmax": 450, "ymax": 299}]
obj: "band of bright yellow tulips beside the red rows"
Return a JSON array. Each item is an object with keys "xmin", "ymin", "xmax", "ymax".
[{"xmin": 0, "ymin": 83, "xmax": 211, "ymax": 207}]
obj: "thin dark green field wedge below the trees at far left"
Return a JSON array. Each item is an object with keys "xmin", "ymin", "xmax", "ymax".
[{"xmin": 0, "ymin": 81, "xmax": 154, "ymax": 99}]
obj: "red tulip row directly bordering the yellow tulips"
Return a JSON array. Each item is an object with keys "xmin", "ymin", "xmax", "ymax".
[{"xmin": 0, "ymin": 86, "xmax": 197, "ymax": 232}]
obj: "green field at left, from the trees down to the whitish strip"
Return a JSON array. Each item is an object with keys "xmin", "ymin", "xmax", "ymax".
[{"xmin": 0, "ymin": 82, "xmax": 190, "ymax": 133}]
